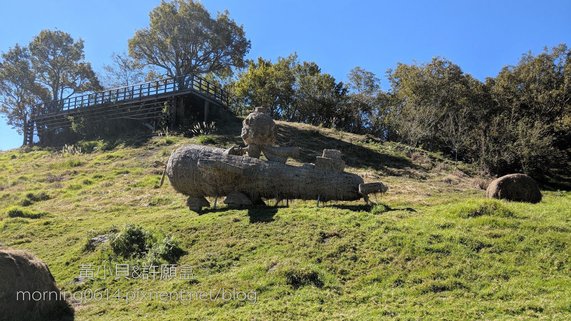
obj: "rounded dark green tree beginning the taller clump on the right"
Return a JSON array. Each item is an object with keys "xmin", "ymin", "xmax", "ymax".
[{"xmin": 389, "ymin": 58, "xmax": 482, "ymax": 151}]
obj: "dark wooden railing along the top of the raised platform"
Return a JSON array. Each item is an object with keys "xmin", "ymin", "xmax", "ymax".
[{"xmin": 34, "ymin": 75, "xmax": 229, "ymax": 118}]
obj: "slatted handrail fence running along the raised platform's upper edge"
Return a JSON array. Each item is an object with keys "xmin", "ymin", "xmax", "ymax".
[{"xmin": 33, "ymin": 74, "xmax": 229, "ymax": 115}]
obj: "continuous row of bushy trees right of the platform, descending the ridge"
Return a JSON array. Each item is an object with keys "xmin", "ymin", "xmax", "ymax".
[{"xmin": 235, "ymin": 45, "xmax": 571, "ymax": 180}]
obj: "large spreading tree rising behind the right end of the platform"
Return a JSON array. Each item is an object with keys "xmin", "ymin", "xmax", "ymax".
[{"xmin": 129, "ymin": 0, "xmax": 250, "ymax": 86}]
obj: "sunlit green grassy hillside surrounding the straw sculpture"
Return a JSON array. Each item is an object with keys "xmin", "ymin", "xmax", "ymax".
[{"xmin": 0, "ymin": 123, "xmax": 571, "ymax": 320}]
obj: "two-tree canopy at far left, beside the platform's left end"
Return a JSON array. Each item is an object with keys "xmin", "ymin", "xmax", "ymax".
[{"xmin": 0, "ymin": 30, "xmax": 101, "ymax": 141}]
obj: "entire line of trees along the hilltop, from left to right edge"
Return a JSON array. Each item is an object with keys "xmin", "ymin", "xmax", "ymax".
[{"xmin": 0, "ymin": 0, "xmax": 571, "ymax": 178}]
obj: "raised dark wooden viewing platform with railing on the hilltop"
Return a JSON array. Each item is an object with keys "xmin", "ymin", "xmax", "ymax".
[{"xmin": 24, "ymin": 75, "xmax": 229, "ymax": 145}]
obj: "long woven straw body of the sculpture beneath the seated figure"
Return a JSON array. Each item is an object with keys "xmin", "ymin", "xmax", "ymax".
[{"xmin": 166, "ymin": 109, "xmax": 387, "ymax": 212}]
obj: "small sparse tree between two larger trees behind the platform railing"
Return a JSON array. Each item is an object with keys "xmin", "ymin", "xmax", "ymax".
[{"xmin": 103, "ymin": 53, "xmax": 146, "ymax": 88}]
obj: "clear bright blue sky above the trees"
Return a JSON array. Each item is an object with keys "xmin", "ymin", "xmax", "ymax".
[{"xmin": 0, "ymin": 0, "xmax": 571, "ymax": 150}]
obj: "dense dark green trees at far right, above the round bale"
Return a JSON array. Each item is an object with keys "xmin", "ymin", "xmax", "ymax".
[{"xmin": 388, "ymin": 45, "xmax": 571, "ymax": 180}]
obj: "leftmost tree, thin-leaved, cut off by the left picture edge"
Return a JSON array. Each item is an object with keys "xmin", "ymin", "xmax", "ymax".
[{"xmin": 0, "ymin": 45, "xmax": 47, "ymax": 143}]
